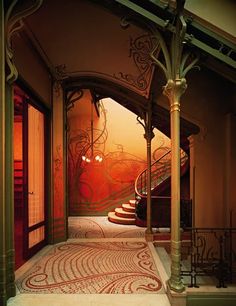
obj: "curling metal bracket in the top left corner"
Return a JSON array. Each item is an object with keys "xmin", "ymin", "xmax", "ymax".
[{"xmin": 5, "ymin": 0, "xmax": 43, "ymax": 84}]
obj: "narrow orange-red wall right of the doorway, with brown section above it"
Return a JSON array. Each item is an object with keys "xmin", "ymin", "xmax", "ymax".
[{"xmin": 13, "ymin": 33, "xmax": 67, "ymax": 243}]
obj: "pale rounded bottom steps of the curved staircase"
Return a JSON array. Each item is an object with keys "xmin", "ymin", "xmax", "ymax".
[{"xmin": 108, "ymin": 200, "xmax": 136, "ymax": 225}]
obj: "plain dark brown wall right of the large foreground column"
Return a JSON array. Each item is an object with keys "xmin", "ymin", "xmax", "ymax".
[{"xmin": 159, "ymin": 68, "xmax": 236, "ymax": 227}]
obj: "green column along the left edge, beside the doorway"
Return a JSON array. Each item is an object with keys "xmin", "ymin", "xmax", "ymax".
[{"xmin": 0, "ymin": 1, "xmax": 15, "ymax": 305}]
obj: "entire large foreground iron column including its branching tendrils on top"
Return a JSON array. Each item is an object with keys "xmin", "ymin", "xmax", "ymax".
[{"xmin": 150, "ymin": 0, "xmax": 199, "ymax": 292}]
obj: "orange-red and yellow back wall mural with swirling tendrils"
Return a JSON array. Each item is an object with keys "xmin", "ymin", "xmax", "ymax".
[{"xmin": 67, "ymin": 90, "xmax": 169, "ymax": 215}]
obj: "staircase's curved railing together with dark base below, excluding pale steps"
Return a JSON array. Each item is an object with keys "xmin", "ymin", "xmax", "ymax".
[{"xmin": 135, "ymin": 150, "xmax": 192, "ymax": 227}]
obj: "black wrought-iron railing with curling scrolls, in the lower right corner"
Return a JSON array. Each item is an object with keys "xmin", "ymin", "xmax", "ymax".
[{"xmin": 181, "ymin": 228, "xmax": 236, "ymax": 288}]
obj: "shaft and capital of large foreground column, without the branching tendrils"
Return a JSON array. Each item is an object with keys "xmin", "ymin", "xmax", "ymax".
[{"xmin": 164, "ymin": 78, "xmax": 186, "ymax": 292}]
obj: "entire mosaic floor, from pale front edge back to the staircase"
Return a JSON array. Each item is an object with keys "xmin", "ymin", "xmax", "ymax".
[{"xmin": 7, "ymin": 217, "xmax": 170, "ymax": 306}]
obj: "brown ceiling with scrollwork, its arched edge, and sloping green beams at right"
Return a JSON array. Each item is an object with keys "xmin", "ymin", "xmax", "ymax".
[{"xmin": 8, "ymin": 0, "xmax": 236, "ymax": 136}]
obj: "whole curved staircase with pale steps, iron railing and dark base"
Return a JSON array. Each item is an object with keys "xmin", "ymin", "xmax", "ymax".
[{"xmin": 108, "ymin": 150, "xmax": 191, "ymax": 227}]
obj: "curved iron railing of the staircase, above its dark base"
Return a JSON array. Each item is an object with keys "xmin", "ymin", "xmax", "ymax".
[{"xmin": 135, "ymin": 150, "xmax": 188, "ymax": 198}]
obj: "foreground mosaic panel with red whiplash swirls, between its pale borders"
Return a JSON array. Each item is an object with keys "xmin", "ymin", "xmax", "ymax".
[{"xmin": 16, "ymin": 242, "xmax": 162, "ymax": 294}]
